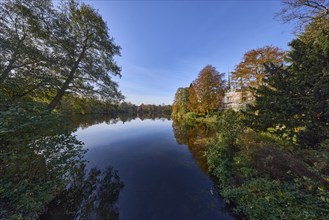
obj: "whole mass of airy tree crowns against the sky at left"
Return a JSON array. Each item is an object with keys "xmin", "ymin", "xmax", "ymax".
[{"xmin": 0, "ymin": 0, "xmax": 124, "ymax": 110}]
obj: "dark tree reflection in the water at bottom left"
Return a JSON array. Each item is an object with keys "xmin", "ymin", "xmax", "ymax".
[{"xmin": 41, "ymin": 167, "xmax": 124, "ymax": 220}]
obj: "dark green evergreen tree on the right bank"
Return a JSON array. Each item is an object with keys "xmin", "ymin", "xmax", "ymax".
[{"xmin": 249, "ymin": 18, "xmax": 329, "ymax": 147}]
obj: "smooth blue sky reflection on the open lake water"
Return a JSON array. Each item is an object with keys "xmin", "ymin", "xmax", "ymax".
[{"xmin": 76, "ymin": 119, "xmax": 230, "ymax": 219}]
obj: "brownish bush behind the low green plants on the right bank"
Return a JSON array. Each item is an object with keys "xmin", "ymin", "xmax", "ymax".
[{"xmin": 234, "ymin": 129, "xmax": 316, "ymax": 181}]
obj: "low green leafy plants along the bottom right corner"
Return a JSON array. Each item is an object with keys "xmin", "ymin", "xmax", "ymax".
[{"xmin": 222, "ymin": 178, "xmax": 329, "ymax": 219}]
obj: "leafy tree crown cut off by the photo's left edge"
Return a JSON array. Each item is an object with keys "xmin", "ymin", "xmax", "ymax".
[{"xmin": 0, "ymin": 0, "xmax": 52, "ymax": 100}]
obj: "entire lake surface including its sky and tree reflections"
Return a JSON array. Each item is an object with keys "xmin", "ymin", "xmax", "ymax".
[{"xmin": 38, "ymin": 115, "xmax": 231, "ymax": 219}]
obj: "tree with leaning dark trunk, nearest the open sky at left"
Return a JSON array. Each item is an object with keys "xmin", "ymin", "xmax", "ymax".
[{"xmin": 48, "ymin": 1, "xmax": 123, "ymax": 109}]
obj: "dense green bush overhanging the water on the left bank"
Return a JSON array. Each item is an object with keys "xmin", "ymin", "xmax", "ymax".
[{"xmin": 0, "ymin": 103, "xmax": 85, "ymax": 219}]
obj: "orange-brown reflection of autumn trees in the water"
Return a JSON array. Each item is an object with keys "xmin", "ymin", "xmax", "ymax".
[{"xmin": 172, "ymin": 120, "xmax": 215, "ymax": 173}]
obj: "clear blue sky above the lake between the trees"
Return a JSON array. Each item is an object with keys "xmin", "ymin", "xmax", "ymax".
[{"xmin": 84, "ymin": 0, "xmax": 294, "ymax": 104}]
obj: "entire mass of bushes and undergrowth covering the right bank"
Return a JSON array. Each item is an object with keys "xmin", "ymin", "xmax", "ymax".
[{"xmin": 206, "ymin": 111, "xmax": 329, "ymax": 219}]
